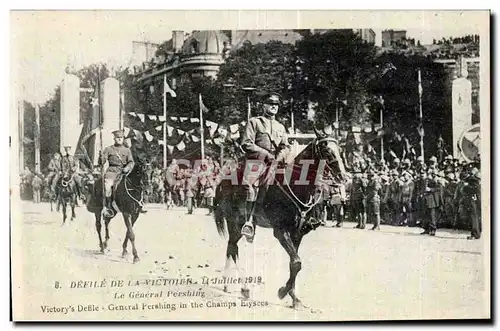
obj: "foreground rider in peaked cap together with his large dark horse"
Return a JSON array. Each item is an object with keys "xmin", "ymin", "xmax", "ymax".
[{"xmin": 214, "ymin": 94, "xmax": 346, "ymax": 308}]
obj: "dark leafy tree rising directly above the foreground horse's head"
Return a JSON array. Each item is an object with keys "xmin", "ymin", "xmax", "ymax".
[{"xmin": 296, "ymin": 30, "xmax": 379, "ymax": 129}]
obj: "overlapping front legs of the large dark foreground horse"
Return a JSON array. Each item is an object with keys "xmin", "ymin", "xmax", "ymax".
[{"xmin": 274, "ymin": 227, "xmax": 302, "ymax": 308}]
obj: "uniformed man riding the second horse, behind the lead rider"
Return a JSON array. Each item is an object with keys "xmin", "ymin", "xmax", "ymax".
[{"xmin": 99, "ymin": 130, "xmax": 145, "ymax": 218}]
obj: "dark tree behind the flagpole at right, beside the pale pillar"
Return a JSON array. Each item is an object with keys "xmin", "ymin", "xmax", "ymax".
[{"xmin": 373, "ymin": 54, "xmax": 452, "ymax": 155}]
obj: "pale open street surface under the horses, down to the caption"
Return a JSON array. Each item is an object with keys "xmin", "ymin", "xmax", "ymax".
[{"xmin": 12, "ymin": 202, "xmax": 490, "ymax": 321}]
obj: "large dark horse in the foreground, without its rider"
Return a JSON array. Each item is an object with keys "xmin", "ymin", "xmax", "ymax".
[{"xmin": 214, "ymin": 133, "xmax": 345, "ymax": 308}]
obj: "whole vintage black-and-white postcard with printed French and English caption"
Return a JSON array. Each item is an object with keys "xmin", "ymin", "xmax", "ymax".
[{"xmin": 10, "ymin": 10, "xmax": 492, "ymax": 321}]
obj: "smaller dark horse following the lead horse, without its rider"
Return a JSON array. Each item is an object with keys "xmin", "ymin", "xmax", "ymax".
[{"xmin": 87, "ymin": 157, "xmax": 150, "ymax": 263}]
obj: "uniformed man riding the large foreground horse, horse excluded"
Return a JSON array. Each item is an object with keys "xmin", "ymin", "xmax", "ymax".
[{"xmin": 241, "ymin": 93, "xmax": 290, "ymax": 241}]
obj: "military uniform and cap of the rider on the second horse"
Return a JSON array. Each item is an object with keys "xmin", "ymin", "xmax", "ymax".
[{"xmin": 101, "ymin": 130, "xmax": 135, "ymax": 217}]
